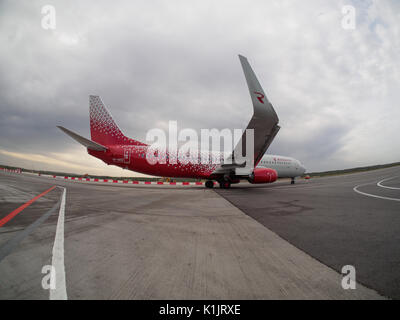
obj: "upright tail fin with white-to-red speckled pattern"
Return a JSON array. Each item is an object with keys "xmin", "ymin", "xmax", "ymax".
[{"xmin": 89, "ymin": 96, "xmax": 146, "ymax": 146}]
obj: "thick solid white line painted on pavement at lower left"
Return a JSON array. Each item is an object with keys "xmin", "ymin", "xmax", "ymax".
[{"xmin": 50, "ymin": 187, "xmax": 67, "ymax": 300}]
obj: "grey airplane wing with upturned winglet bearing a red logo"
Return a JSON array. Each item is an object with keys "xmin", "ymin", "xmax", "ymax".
[{"xmin": 213, "ymin": 55, "xmax": 280, "ymax": 174}]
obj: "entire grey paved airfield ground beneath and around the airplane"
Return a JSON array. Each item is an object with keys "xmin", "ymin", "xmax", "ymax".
[{"xmin": 0, "ymin": 168, "xmax": 400, "ymax": 299}]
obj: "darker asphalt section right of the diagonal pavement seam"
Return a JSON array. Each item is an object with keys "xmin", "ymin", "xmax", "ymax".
[{"xmin": 217, "ymin": 167, "xmax": 400, "ymax": 299}]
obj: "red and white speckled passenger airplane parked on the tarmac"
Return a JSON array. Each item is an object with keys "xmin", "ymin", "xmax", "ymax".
[{"xmin": 57, "ymin": 55, "xmax": 306, "ymax": 189}]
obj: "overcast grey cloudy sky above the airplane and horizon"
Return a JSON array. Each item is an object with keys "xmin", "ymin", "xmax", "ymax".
[{"xmin": 0, "ymin": 0, "xmax": 400, "ymax": 176}]
